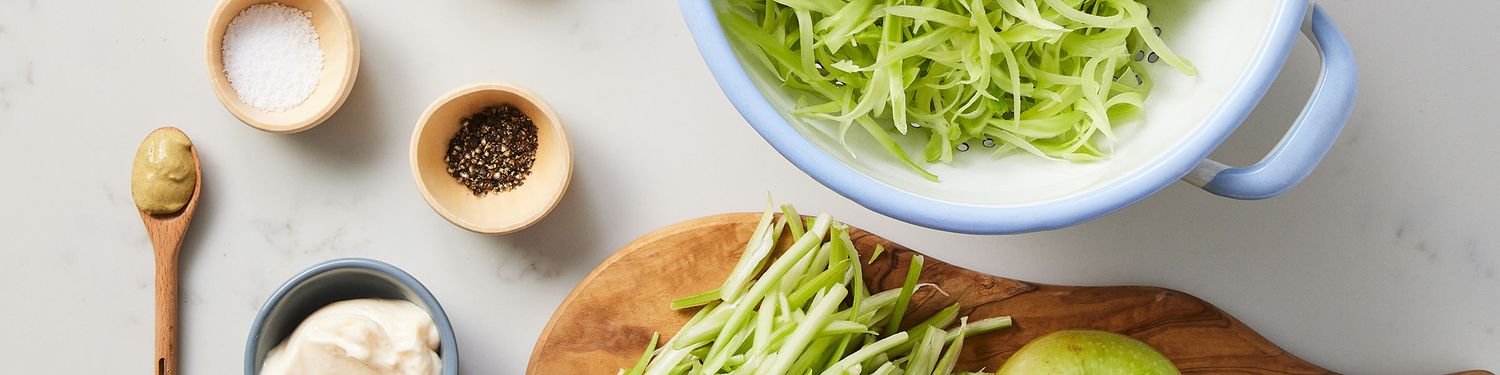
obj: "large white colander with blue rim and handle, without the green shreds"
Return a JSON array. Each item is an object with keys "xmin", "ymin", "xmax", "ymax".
[{"xmin": 680, "ymin": 0, "xmax": 1358, "ymax": 234}]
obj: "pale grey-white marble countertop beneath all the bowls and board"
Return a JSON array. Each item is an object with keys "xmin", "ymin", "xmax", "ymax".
[{"xmin": 0, "ymin": 0, "xmax": 1500, "ymax": 374}]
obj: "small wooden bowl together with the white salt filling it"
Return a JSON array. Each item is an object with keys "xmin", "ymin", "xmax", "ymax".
[{"xmin": 204, "ymin": 0, "xmax": 360, "ymax": 134}]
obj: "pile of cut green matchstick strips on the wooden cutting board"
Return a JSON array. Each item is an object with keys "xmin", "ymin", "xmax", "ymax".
[{"xmin": 620, "ymin": 204, "xmax": 1011, "ymax": 375}]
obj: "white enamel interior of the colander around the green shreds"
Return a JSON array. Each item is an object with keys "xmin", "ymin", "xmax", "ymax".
[{"xmin": 714, "ymin": 0, "xmax": 1284, "ymax": 207}]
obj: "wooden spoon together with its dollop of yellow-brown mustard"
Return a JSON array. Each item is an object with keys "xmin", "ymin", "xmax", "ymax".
[{"xmin": 131, "ymin": 126, "xmax": 203, "ymax": 375}]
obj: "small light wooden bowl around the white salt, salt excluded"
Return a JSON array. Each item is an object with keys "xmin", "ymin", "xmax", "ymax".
[{"xmin": 204, "ymin": 0, "xmax": 360, "ymax": 134}]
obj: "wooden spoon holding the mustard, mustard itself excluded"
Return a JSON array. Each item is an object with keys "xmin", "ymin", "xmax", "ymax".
[{"xmin": 137, "ymin": 126, "xmax": 203, "ymax": 375}]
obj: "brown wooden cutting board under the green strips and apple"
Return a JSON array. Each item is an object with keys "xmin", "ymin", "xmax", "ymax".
[{"xmin": 527, "ymin": 213, "xmax": 1490, "ymax": 375}]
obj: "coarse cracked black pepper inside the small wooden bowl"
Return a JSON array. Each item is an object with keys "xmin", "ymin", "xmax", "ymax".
[{"xmin": 443, "ymin": 105, "xmax": 537, "ymax": 195}]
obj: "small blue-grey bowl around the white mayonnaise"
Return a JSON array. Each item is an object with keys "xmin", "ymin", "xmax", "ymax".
[{"xmin": 245, "ymin": 258, "xmax": 459, "ymax": 375}]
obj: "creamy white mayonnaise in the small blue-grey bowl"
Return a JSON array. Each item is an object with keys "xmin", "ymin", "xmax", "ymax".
[{"xmin": 261, "ymin": 299, "xmax": 443, "ymax": 375}]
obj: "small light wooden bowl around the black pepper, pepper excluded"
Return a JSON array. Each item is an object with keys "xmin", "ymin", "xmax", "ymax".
[{"xmin": 411, "ymin": 84, "xmax": 573, "ymax": 234}]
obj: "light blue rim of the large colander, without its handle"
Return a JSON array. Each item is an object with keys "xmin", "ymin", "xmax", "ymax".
[{"xmin": 680, "ymin": 0, "xmax": 1311, "ymax": 234}]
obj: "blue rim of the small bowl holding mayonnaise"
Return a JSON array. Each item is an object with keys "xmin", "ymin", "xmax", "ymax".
[{"xmin": 245, "ymin": 258, "xmax": 459, "ymax": 375}]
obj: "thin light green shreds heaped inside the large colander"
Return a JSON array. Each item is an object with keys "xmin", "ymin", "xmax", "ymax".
[{"xmin": 720, "ymin": 0, "xmax": 1197, "ymax": 180}]
